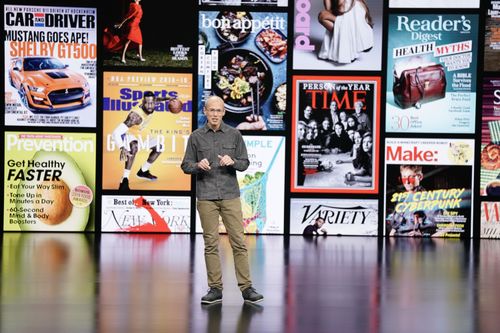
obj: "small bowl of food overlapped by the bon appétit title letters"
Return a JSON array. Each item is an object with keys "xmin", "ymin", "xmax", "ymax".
[{"xmin": 215, "ymin": 11, "xmax": 252, "ymax": 45}]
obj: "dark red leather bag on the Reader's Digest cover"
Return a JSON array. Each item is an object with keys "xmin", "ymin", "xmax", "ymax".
[{"xmin": 392, "ymin": 64, "xmax": 446, "ymax": 109}]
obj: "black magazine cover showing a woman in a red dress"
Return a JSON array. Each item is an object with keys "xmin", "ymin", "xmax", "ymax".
[{"xmin": 101, "ymin": 0, "xmax": 192, "ymax": 68}]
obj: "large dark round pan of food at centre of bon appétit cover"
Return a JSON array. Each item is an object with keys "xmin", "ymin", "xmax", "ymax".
[{"xmin": 212, "ymin": 49, "xmax": 273, "ymax": 113}]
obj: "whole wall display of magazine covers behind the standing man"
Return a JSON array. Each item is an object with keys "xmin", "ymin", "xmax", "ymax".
[{"xmin": 2, "ymin": 0, "xmax": 500, "ymax": 238}]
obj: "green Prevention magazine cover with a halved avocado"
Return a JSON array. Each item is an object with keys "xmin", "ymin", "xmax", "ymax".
[{"xmin": 3, "ymin": 132, "xmax": 96, "ymax": 232}]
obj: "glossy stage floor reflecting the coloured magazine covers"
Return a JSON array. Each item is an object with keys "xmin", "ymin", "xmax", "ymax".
[{"xmin": 0, "ymin": 233, "xmax": 500, "ymax": 333}]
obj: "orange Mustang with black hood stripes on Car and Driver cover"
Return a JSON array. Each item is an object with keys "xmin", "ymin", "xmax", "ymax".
[{"xmin": 9, "ymin": 57, "xmax": 91, "ymax": 112}]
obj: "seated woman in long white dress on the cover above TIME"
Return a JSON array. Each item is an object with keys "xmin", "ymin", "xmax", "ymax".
[{"xmin": 318, "ymin": 0, "xmax": 373, "ymax": 63}]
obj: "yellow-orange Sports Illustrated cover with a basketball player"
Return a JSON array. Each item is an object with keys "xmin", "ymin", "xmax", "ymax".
[{"xmin": 102, "ymin": 72, "xmax": 193, "ymax": 193}]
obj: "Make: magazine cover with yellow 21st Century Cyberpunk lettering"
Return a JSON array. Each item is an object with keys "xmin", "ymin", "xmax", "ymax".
[{"xmin": 384, "ymin": 138, "xmax": 474, "ymax": 238}]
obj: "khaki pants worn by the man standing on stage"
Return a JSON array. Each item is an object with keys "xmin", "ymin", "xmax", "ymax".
[{"xmin": 197, "ymin": 198, "xmax": 252, "ymax": 291}]
